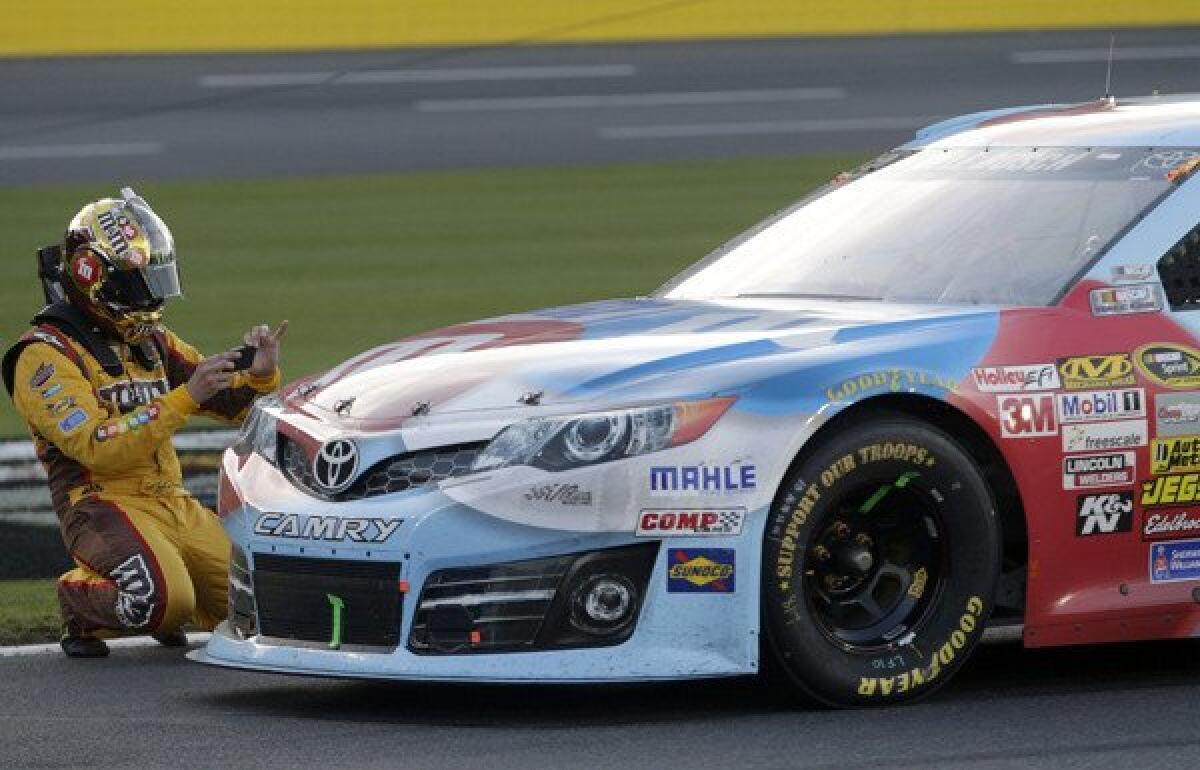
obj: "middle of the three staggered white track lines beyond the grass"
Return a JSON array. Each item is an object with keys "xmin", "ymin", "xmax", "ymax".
[{"xmin": 416, "ymin": 88, "xmax": 846, "ymax": 113}]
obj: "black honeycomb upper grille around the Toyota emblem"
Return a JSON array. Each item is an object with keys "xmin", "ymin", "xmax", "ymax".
[{"xmin": 280, "ymin": 437, "xmax": 487, "ymax": 503}]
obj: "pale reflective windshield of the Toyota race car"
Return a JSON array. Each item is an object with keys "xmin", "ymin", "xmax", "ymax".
[{"xmin": 656, "ymin": 148, "xmax": 1200, "ymax": 305}]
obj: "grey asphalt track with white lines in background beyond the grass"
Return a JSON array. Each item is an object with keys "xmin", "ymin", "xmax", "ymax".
[{"xmin": 0, "ymin": 29, "xmax": 1200, "ymax": 185}]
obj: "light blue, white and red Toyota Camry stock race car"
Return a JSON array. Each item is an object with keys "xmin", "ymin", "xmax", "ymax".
[{"xmin": 192, "ymin": 92, "xmax": 1200, "ymax": 706}]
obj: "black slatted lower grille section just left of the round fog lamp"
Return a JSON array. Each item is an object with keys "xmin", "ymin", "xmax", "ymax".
[{"xmin": 409, "ymin": 557, "xmax": 575, "ymax": 654}]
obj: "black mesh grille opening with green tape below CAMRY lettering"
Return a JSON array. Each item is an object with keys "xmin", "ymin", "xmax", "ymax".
[{"xmin": 253, "ymin": 554, "xmax": 401, "ymax": 646}]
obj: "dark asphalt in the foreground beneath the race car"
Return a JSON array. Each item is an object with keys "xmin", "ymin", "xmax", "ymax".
[{"xmin": 0, "ymin": 642, "xmax": 1200, "ymax": 770}]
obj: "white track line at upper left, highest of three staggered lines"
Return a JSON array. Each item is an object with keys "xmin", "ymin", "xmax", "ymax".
[{"xmin": 198, "ymin": 65, "xmax": 637, "ymax": 89}]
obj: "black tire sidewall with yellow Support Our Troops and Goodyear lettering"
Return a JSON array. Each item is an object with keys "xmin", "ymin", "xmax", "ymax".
[{"xmin": 762, "ymin": 419, "xmax": 1001, "ymax": 706}]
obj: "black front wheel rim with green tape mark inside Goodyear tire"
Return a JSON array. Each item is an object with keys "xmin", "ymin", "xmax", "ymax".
[{"xmin": 803, "ymin": 471, "xmax": 947, "ymax": 652}]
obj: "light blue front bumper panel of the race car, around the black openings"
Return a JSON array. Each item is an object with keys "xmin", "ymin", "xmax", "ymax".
[{"xmin": 190, "ymin": 453, "xmax": 766, "ymax": 682}]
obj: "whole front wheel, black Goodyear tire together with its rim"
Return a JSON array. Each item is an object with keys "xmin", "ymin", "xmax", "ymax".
[{"xmin": 762, "ymin": 415, "xmax": 1001, "ymax": 708}]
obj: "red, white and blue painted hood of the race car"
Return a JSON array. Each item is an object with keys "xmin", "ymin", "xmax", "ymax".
[{"xmin": 287, "ymin": 299, "xmax": 991, "ymax": 429}]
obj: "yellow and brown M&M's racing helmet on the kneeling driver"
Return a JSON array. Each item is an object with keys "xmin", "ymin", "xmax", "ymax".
[{"xmin": 60, "ymin": 187, "xmax": 181, "ymax": 344}]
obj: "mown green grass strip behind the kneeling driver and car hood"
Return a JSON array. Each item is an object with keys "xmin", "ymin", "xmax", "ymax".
[{"xmin": 0, "ymin": 155, "xmax": 863, "ymax": 437}]
